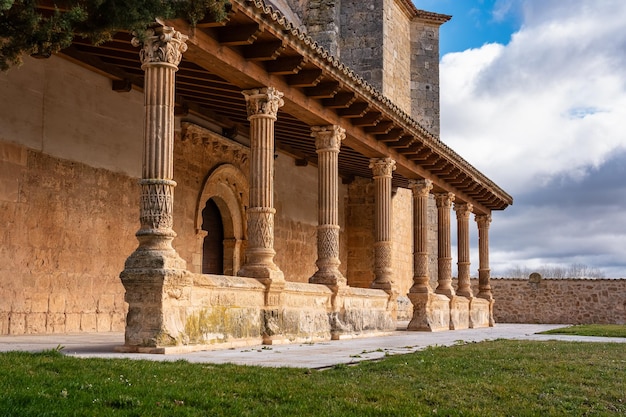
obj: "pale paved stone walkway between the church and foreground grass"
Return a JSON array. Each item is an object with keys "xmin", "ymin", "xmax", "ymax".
[{"xmin": 0, "ymin": 324, "xmax": 626, "ymax": 369}]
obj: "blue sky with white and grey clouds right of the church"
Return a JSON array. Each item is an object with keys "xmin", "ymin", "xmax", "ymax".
[{"xmin": 414, "ymin": 0, "xmax": 626, "ymax": 277}]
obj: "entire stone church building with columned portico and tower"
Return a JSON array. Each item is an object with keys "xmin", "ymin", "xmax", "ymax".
[{"xmin": 0, "ymin": 0, "xmax": 512, "ymax": 353}]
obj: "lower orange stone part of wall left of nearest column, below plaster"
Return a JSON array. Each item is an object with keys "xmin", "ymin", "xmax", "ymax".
[{"xmin": 0, "ymin": 142, "xmax": 133, "ymax": 335}]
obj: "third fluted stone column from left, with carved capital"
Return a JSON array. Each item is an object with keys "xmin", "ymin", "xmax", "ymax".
[{"xmin": 309, "ymin": 125, "xmax": 347, "ymax": 286}]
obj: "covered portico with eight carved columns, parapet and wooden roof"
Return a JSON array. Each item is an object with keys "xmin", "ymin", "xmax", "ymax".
[{"xmin": 65, "ymin": 0, "xmax": 512, "ymax": 352}]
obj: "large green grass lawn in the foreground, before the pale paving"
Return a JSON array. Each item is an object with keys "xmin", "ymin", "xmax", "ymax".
[{"xmin": 0, "ymin": 340, "xmax": 626, "ymax": 417}]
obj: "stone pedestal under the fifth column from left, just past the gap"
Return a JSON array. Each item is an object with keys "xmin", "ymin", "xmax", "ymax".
[{"xmin": 407, "ymin": 293, "xmax": 450, "ymax": 332}]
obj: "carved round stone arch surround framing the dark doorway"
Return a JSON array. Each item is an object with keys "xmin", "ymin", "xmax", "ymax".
[{"xmin": 194, "ymin": 164, "xmax": 250, "ymax": 275}]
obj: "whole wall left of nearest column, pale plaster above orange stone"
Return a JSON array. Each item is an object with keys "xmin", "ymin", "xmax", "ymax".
[{"xmin": 0, "ymin": 56, "xmax": 143, "ymax": 334}]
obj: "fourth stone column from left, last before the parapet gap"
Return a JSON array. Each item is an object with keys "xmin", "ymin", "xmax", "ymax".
[{"xmin": 370, "ymin": 158, "xmax": 396, "ymax": 293}]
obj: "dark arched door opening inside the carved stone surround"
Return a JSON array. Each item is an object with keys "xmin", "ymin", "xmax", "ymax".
[{"xmin": 202, "ymin": 198, "xmax": 224, "ymax": 275}]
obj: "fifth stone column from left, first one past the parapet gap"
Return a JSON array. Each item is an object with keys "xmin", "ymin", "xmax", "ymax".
[{"xmin": 409, "ymin": 180, "xmax": 433, "ymax": 294}]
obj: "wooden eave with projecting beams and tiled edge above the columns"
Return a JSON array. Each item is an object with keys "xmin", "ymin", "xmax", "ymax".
[{"xmin": 52, "ymin": 0, "xmax": 513, "ymax": 213}]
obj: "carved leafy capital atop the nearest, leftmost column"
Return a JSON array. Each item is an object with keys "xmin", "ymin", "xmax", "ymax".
[{"xmin": 131, "ymin": 22, "xmax": 189, "ymax": 68}]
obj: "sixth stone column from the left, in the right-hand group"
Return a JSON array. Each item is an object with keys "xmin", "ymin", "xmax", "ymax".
[{"xmin": 435, "ymin": 193, "xmax": 454, "ymax": 298}]
